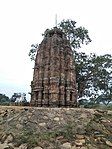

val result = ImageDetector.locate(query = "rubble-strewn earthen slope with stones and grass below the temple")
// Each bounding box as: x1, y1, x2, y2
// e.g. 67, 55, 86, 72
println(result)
0, 106, 112, 149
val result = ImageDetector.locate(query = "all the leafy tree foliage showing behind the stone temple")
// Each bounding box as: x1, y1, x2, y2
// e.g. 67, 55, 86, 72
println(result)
30, 20, 112, 104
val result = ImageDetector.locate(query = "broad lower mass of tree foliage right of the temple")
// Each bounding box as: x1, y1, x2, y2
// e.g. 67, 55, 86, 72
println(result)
74, 53, 112, 103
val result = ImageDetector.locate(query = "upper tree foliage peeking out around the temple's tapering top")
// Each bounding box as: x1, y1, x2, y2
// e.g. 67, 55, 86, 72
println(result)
28, 20, 91, 60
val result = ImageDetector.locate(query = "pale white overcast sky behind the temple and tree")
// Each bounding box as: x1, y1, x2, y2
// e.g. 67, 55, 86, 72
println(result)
0, 0, 112, 100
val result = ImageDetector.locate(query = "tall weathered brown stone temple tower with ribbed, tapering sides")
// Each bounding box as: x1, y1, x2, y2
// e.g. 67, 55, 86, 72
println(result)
30, 27, 77, 107
